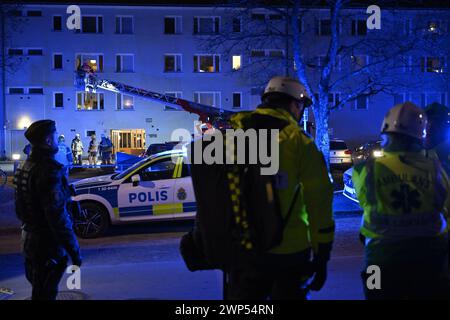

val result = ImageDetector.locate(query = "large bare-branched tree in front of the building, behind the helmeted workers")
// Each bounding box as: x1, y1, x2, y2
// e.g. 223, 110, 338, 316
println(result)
201, 0, 450, 163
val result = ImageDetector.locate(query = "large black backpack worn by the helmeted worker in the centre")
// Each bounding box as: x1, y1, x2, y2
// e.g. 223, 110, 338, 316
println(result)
180, 113, 299, 271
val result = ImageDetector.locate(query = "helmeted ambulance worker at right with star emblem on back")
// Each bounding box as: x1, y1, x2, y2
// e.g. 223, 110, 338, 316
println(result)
352, 102, 450, 299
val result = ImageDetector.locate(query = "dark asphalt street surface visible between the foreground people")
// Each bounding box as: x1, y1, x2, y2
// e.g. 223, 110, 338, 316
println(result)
0, 165, 363, 300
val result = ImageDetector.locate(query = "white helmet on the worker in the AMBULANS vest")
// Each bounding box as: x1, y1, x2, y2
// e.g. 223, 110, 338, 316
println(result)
381, 101, 427, 140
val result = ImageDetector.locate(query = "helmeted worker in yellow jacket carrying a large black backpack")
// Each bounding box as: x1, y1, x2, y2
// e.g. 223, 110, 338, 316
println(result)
229, 77, 334, 299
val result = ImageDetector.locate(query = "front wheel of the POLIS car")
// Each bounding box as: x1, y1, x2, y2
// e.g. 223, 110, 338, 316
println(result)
74, 202, 109, 239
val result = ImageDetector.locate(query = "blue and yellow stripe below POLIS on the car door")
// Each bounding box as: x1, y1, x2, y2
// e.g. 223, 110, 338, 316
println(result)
119, 202, 197, 218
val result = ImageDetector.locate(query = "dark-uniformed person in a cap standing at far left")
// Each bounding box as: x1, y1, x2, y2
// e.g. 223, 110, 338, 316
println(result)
14, 120, 82, 300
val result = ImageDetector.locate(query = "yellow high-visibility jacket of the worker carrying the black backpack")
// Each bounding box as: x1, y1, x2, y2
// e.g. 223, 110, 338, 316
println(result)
231, 108, 334, 254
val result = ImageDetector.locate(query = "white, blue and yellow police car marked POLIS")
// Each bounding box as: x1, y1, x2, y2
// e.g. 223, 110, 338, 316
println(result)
74, 150, 196, 238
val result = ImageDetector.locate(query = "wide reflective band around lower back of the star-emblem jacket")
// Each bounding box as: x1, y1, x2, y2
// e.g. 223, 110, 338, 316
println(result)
363, 213, 447, 238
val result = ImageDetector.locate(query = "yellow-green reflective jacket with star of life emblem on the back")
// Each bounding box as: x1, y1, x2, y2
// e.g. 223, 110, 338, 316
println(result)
352, 151, 450, 240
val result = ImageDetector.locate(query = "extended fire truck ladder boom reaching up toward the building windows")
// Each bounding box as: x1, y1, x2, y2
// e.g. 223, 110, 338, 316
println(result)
75, 70, 234, 127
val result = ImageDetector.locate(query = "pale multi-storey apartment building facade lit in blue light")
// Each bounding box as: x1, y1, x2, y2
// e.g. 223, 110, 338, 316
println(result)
4, 4, 450, 157
